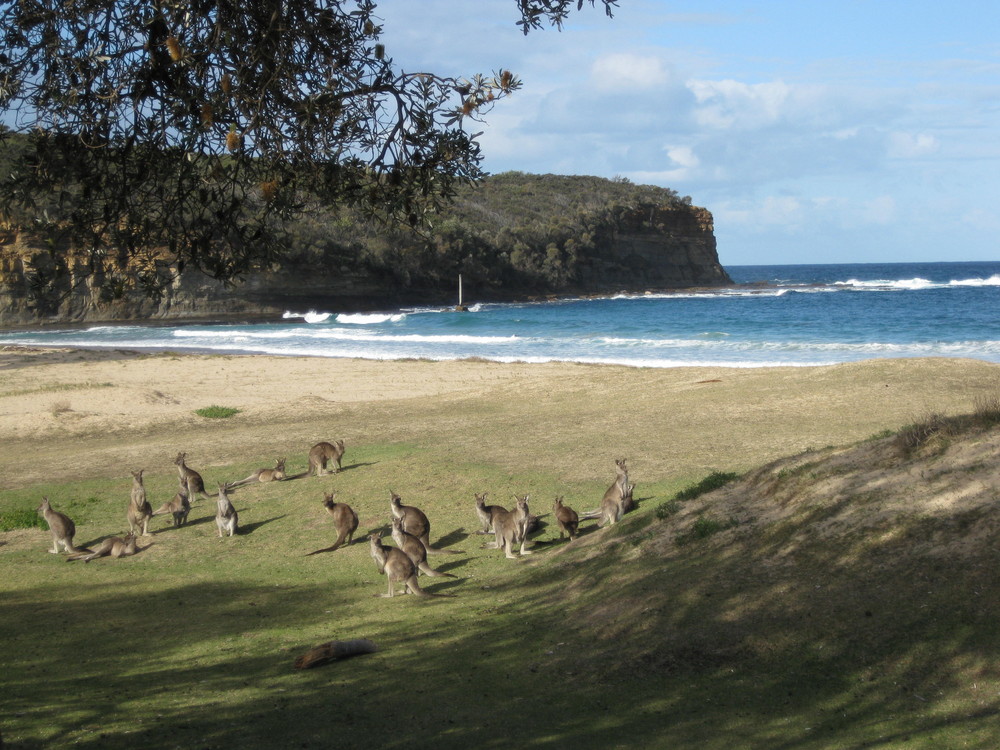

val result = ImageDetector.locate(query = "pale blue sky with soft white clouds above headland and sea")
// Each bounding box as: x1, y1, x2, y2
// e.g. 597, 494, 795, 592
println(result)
377, 0, 1000, 265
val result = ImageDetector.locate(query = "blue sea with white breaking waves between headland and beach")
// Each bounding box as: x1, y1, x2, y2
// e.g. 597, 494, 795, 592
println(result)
0, 262, 1000, 367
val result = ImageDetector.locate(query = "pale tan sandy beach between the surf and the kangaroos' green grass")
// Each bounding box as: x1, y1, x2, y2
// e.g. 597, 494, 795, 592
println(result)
0, 347, 1000, 488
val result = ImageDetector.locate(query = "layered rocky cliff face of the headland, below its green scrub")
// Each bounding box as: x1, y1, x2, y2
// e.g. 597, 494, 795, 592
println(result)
0, 176, 731, 327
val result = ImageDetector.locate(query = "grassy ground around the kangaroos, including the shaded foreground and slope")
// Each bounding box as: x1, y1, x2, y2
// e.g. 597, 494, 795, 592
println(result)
0, 356, 1000, 750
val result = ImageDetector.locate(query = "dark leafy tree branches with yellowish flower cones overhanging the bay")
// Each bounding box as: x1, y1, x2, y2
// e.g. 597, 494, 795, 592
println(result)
0, 0, 616, 294
